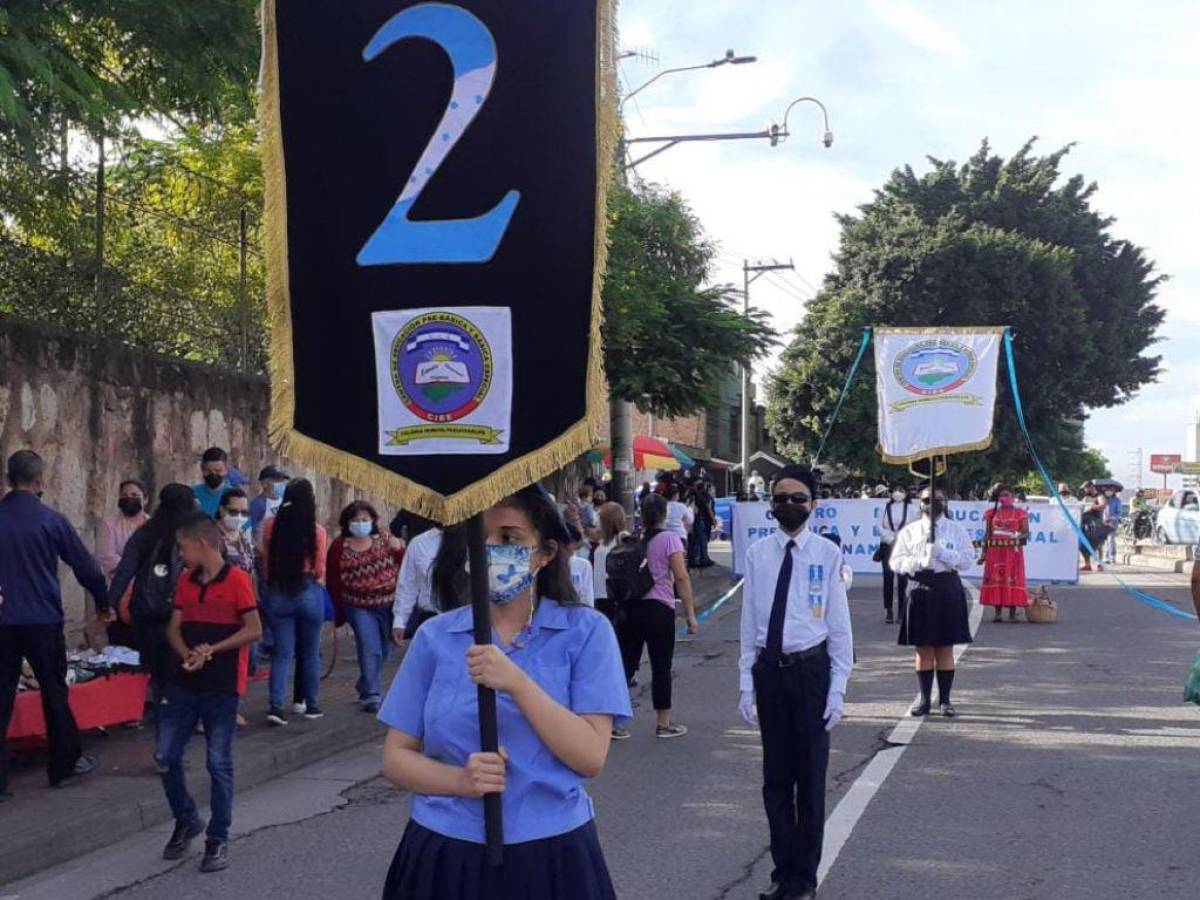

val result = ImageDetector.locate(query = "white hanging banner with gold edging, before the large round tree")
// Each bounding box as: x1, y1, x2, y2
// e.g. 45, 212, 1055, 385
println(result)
875, 328, 1004, 463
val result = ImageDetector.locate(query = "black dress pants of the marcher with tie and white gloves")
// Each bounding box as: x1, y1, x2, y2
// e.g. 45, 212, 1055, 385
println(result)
751, 644, 829, 894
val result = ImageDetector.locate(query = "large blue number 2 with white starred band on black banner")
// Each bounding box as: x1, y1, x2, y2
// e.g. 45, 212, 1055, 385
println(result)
358, 4, 521, 265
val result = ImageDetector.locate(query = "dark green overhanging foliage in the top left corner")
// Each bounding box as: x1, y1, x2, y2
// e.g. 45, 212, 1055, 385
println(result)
0, 0, 258, 154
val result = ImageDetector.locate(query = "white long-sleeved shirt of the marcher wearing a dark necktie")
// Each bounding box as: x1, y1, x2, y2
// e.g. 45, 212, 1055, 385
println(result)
738, 528, 854, 694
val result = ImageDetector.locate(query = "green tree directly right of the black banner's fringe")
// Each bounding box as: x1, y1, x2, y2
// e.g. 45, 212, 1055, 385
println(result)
604, 184, 775, 416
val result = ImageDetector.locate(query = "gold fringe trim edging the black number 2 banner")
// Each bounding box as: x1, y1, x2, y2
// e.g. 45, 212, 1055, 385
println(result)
259, 0, 618, 524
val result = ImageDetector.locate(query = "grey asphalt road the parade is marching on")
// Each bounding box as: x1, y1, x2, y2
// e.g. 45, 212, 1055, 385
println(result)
11, 561, 1200, 900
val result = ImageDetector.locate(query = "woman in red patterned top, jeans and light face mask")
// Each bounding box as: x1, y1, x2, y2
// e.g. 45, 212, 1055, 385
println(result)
325, 500, 404, 713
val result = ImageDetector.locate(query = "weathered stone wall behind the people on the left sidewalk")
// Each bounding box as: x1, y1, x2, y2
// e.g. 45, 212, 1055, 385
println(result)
0, 314, 367, 642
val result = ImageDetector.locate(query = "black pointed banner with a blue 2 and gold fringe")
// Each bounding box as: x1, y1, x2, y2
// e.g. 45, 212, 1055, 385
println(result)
263, 0, 613, 522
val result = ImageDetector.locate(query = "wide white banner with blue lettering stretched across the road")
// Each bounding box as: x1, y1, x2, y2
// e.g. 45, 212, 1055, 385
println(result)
733, 500, 1079, 583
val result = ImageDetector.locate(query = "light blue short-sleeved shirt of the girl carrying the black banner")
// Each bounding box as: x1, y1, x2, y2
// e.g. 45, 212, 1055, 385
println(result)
379, 600, 632, 844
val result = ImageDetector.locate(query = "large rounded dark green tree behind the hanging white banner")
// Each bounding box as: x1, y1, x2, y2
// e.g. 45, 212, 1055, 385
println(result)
768, 140, 1163, 486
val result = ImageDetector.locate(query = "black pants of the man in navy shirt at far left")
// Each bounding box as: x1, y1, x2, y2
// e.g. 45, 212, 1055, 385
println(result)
0, 624, 83, 791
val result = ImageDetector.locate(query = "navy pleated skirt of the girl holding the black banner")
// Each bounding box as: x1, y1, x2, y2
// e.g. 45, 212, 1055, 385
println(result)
383, 820, 617, 900
